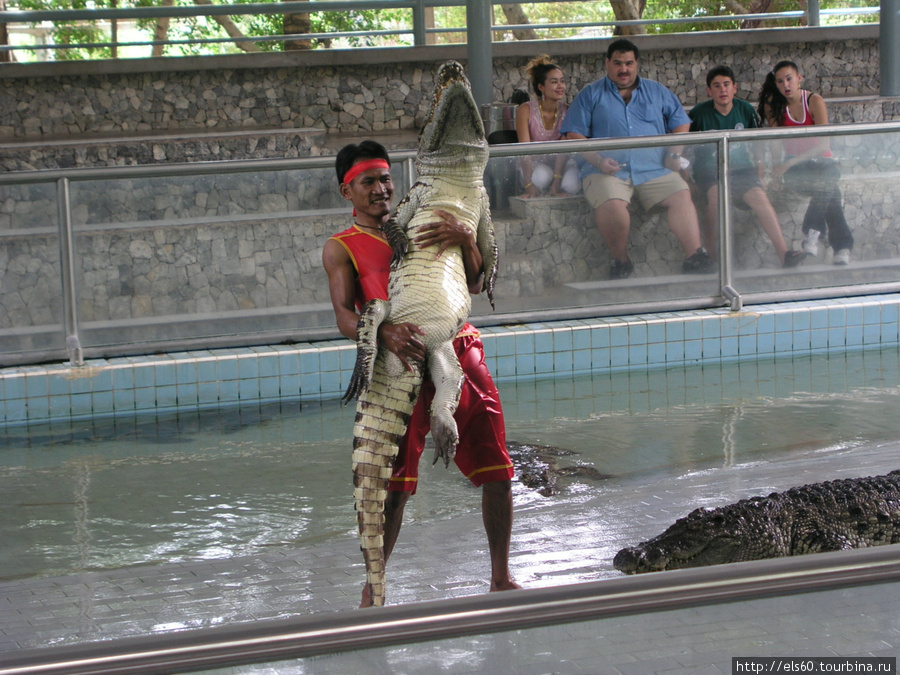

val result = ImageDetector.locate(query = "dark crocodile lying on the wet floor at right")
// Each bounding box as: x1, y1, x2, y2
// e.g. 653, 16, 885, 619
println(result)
613, 471, 900, 574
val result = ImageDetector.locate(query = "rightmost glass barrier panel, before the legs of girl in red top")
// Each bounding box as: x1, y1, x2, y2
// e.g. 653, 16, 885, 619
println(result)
729, 131, 900, 293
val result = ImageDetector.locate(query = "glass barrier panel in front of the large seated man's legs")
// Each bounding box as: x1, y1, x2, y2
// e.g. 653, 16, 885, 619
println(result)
475, 141, 719, 324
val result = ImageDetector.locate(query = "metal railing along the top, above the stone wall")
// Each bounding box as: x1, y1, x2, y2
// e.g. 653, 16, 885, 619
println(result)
0, 0, 879, 55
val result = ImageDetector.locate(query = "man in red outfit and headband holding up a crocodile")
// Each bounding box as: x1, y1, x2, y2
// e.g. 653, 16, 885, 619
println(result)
322, 141, 519, 607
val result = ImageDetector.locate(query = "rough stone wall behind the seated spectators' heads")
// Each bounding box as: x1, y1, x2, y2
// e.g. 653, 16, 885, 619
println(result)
0, 26, 879, 148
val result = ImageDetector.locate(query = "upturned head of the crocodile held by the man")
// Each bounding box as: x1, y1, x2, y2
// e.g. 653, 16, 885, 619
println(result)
416, 61, 488, 180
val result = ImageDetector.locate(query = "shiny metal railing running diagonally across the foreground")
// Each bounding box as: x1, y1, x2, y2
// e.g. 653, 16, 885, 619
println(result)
0, 545, 900, 675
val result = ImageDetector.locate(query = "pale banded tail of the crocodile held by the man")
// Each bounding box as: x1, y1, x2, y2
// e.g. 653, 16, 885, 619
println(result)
353, 352, 422, 606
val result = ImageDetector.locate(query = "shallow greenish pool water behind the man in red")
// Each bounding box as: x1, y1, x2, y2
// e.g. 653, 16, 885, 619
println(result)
0, 348, 900, 580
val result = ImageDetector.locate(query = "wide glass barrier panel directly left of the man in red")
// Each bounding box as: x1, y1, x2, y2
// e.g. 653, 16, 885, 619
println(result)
72, 167, 405, 354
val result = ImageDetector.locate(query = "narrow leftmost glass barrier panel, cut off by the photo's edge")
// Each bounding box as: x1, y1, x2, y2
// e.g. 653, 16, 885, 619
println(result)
0, 183, 65, 357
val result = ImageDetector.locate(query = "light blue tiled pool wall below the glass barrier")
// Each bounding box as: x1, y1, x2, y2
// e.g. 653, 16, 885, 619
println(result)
0, 294, 900, 426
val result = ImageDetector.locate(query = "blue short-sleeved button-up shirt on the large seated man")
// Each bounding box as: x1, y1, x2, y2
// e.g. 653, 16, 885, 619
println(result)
561, 77, 691, 185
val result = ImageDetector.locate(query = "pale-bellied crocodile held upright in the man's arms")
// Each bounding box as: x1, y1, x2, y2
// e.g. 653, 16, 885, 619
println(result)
344, 61, 497, 605
